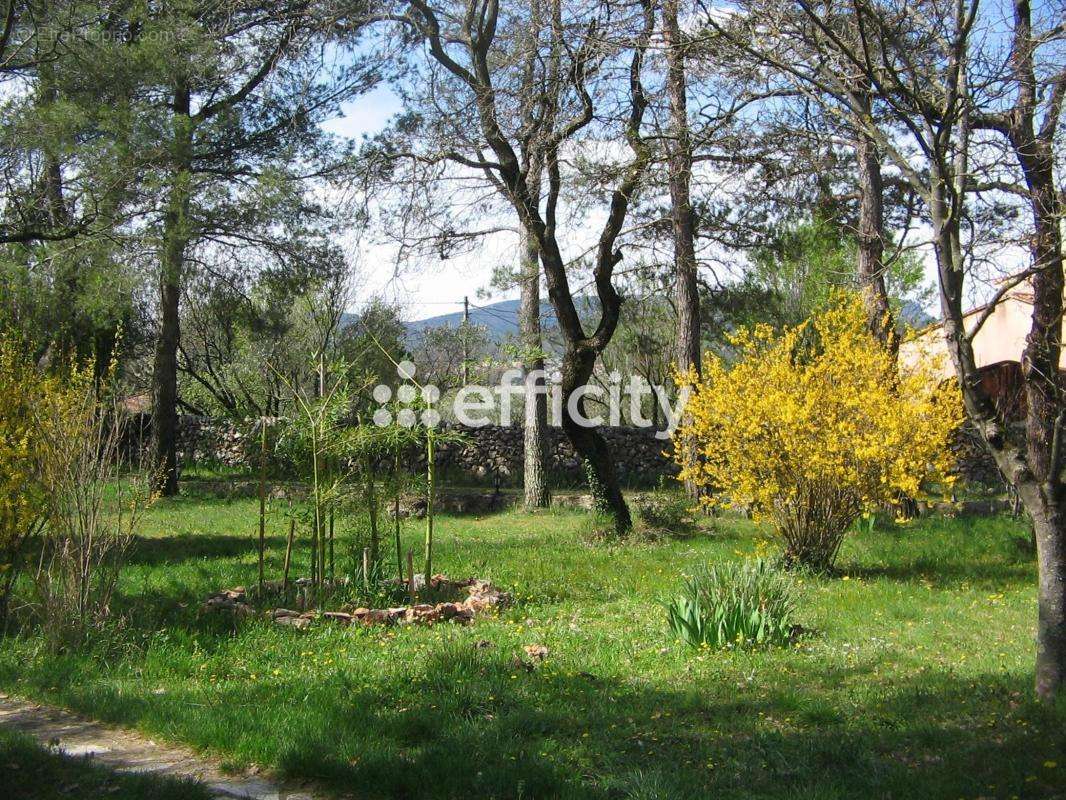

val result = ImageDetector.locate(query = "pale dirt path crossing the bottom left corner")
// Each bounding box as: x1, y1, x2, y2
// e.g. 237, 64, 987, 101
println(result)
0, 694, 326, 800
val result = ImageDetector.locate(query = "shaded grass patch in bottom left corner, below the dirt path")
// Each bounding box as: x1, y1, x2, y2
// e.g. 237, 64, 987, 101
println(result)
0, 727, 210, 800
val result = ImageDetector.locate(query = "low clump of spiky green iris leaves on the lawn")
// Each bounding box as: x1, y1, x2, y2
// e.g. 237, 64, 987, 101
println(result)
666, 559, 795, 647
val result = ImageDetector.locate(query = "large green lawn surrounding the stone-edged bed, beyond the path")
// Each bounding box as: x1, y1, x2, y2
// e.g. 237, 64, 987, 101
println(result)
0, 498, 1066, 799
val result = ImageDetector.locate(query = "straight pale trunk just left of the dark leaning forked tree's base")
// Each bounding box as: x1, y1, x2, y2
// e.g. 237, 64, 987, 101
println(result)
518, 233, 551, 510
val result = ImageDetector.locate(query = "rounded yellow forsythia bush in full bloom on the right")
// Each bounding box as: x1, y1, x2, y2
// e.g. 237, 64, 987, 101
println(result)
675, 294, 963, 570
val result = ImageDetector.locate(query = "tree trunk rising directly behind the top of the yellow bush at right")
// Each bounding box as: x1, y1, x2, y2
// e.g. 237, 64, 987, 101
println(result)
855, 85, 900, 355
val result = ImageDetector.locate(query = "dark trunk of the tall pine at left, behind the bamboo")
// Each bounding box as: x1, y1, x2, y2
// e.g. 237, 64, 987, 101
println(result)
151, 85, 192, 497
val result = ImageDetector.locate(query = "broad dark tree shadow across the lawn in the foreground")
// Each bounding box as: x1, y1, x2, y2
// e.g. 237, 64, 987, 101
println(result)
108, 641, 1066, 799
